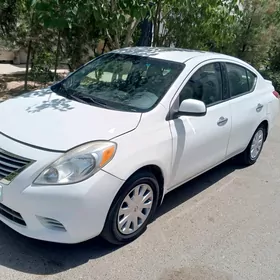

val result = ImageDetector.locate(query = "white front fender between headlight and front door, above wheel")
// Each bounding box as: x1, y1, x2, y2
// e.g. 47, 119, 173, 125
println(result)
103, 118, 172, 188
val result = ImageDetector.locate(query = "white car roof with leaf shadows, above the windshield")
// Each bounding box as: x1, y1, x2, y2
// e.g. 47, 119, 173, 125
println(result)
112, 47, 233, 63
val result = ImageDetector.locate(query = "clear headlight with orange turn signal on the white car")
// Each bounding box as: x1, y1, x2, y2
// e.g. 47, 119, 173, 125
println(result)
34, 141, 116, 185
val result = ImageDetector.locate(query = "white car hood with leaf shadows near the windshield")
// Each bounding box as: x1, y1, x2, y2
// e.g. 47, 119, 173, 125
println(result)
0, 89, 141, 151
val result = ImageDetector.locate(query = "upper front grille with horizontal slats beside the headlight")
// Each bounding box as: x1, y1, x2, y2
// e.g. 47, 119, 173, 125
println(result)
0, 149, 32, 184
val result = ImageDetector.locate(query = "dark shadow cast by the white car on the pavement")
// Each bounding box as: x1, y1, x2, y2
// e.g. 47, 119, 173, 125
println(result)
0, 161, 245, 275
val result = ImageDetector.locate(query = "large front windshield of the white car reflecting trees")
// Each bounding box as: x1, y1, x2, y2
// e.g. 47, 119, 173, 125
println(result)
52, 53, 184, 112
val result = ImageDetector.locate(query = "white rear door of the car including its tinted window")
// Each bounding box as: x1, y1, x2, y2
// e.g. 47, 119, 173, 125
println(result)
225, 63, 267, 157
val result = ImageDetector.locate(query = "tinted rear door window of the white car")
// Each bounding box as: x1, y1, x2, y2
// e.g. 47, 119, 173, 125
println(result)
226, 63, 257, 96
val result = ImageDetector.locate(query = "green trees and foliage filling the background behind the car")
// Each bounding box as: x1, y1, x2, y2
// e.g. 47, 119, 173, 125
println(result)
0, 0, 280, 88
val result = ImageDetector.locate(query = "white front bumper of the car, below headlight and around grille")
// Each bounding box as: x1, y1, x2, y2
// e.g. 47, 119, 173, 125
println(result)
0, 136, 123, 243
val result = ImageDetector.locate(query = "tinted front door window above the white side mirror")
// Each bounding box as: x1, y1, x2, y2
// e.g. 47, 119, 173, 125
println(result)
180, 63, 223, 105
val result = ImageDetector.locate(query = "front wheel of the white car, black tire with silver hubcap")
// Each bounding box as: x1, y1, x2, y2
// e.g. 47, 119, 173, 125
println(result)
101, 171, 159, 245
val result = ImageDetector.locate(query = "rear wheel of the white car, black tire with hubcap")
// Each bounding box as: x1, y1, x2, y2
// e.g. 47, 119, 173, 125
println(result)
239, 125, 266, 166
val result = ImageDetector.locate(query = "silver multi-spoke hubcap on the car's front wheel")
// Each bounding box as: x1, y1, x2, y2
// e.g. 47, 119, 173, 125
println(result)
117, 184, 154, 235
